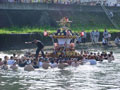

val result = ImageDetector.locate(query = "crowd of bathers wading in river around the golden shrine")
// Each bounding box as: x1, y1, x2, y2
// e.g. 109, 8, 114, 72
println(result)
0, 51, 114, 71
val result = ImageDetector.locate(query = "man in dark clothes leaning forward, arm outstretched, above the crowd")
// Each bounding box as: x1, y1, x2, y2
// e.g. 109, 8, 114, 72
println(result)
25, 39, 45, 59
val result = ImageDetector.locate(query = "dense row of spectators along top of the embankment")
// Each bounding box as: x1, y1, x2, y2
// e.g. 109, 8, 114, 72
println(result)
0, 0, 120, 7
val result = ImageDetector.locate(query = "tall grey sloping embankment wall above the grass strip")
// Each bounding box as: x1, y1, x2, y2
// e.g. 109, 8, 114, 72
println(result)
0, 3, 120, 28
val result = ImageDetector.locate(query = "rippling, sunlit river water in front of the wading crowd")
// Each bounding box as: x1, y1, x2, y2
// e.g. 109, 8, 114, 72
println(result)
0, 48, 120, 90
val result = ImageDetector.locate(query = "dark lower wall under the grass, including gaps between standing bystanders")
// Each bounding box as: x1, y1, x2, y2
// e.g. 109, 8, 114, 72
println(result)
0, 32, 120, 51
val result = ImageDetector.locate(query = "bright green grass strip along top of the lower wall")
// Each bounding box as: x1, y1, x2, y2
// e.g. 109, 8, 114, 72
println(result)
0, 27, 120, 34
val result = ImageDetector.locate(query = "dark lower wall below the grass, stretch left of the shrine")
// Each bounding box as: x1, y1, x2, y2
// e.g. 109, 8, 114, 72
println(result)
0, 34, 52, 51
